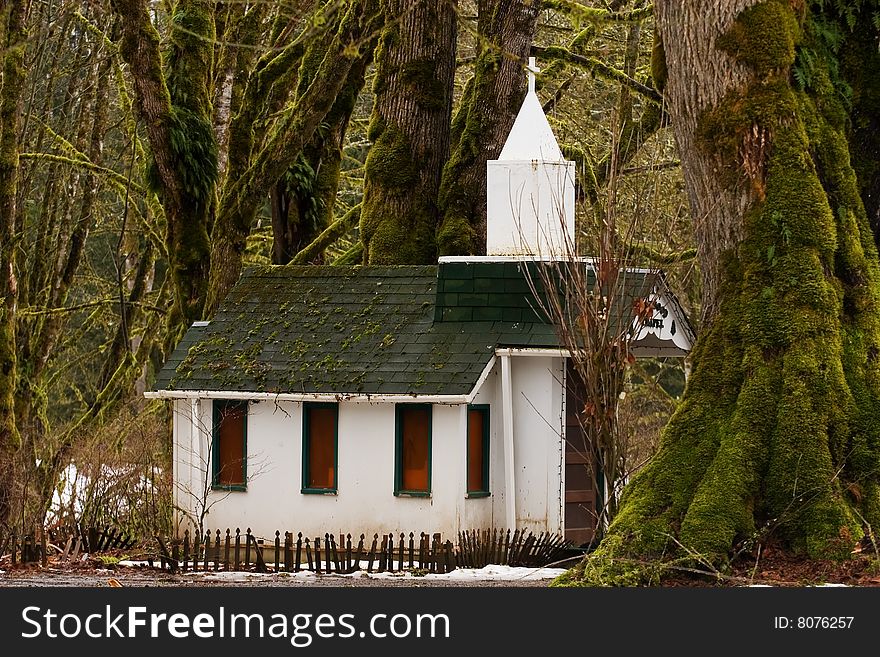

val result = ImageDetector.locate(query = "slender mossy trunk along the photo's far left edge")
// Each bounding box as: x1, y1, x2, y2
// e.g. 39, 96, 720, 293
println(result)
0, 0, 27, 530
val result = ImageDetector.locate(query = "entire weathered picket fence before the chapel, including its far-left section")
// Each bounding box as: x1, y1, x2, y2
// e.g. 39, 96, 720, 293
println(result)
0, 526, 571, 574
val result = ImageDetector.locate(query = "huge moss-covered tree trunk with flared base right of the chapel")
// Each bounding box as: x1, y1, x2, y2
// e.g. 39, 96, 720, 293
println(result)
574, 0, 880, 583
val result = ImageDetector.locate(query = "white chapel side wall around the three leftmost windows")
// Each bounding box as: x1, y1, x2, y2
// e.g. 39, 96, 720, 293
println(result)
174, 400, 466, 539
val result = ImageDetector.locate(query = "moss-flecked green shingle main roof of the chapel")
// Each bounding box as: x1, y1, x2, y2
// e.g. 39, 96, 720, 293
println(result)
153, 266, 557, 395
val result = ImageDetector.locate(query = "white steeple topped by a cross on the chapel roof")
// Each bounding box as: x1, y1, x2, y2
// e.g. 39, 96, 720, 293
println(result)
486, 57, 574, 256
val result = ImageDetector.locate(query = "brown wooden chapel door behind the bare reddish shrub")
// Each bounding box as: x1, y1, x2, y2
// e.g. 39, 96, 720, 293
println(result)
565, 364, 597, 546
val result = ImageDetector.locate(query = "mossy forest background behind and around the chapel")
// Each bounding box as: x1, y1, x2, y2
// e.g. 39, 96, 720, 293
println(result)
0, 0, 700, 552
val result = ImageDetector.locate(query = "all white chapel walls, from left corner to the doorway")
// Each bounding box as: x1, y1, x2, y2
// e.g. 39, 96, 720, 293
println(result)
174, 356, 564, 540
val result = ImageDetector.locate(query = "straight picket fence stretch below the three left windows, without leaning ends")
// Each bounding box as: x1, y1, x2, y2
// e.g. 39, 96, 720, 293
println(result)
156, 529, 457, 574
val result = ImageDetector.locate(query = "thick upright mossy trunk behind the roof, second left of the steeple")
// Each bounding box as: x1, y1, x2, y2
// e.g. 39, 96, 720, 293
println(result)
360, 0, 457, 264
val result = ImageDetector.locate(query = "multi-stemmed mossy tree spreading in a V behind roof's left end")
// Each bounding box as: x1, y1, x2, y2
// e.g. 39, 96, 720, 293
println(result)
113, 0, 379, 320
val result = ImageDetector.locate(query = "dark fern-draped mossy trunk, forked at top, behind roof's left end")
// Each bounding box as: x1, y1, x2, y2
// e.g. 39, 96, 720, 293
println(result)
112, 0, 217, 326
